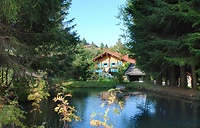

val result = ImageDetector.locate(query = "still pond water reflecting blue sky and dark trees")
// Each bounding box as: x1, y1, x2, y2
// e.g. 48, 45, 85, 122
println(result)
24, 89, 200, 128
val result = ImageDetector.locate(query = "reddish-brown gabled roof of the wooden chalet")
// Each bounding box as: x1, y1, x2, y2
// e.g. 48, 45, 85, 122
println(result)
93, 51, 136, 64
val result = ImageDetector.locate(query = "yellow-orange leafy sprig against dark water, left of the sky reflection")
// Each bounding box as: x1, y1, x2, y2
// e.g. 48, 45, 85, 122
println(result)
53, 93, 80, 123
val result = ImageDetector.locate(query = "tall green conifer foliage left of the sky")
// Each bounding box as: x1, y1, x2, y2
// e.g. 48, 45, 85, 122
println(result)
0, 0, 78, 85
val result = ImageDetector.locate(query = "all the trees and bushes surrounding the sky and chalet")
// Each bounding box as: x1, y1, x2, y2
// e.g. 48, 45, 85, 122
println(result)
0, 0, 200, 126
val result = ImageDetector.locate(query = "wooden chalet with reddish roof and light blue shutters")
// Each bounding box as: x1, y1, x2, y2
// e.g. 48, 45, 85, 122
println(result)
93, 51, 136, 74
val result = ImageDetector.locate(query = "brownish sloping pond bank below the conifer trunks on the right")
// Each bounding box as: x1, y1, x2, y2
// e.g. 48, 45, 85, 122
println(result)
127, 83, 200, 102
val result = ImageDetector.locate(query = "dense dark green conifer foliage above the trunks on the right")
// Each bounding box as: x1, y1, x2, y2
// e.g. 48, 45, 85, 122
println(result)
119, 0, 200, 87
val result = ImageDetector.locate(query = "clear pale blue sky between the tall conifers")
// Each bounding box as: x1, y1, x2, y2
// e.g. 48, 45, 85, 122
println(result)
68, 0, 126, 47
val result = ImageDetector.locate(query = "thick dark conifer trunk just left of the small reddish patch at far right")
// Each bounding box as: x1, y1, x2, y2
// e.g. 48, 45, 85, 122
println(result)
180, 65, 187, 88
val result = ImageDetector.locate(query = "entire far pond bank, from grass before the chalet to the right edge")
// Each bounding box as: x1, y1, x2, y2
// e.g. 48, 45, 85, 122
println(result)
62, 81, 200, 102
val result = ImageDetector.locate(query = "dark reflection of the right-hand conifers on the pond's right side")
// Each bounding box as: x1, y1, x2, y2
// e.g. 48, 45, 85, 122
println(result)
126, 95, 200, 128
